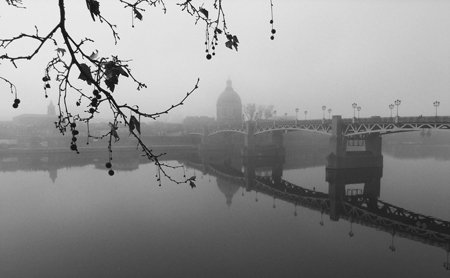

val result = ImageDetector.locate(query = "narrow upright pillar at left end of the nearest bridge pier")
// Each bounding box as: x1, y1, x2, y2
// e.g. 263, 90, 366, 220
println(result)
327, 115, 347, 168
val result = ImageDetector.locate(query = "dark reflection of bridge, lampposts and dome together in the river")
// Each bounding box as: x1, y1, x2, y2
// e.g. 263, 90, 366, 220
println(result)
188, 148, 450, 270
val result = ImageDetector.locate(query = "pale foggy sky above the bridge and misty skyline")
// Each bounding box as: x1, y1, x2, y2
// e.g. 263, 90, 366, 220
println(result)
0, 0, 450, 120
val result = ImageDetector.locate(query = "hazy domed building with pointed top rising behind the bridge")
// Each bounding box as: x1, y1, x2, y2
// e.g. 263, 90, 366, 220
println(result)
216, 79, 242, 123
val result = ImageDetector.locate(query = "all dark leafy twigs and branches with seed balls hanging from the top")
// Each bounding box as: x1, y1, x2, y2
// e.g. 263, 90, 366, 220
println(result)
0, 0, 250, 183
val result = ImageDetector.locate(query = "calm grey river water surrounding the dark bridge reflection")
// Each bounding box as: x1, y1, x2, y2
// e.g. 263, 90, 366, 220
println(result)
0, 144, 450, 277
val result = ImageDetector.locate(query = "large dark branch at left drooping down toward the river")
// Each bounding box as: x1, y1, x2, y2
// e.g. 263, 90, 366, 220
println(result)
0, 0, 204, 184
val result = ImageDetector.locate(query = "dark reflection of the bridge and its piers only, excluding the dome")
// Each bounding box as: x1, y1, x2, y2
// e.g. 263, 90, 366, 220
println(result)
188, 155, 450, 253
